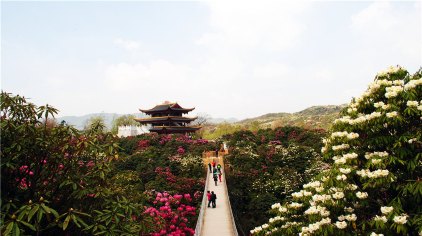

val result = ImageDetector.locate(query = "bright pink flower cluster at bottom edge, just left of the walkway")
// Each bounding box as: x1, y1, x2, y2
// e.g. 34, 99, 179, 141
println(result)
144, 192, 196, 236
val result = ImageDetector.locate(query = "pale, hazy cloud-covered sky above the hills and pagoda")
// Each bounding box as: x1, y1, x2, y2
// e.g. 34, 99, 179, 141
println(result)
1, 0, 422, 119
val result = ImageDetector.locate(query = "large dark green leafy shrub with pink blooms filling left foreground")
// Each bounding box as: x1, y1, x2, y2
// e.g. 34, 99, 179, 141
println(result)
0, 92, 142, 235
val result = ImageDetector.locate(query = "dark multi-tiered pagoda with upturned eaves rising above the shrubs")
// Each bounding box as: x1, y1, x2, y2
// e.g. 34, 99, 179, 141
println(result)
135, 101, 201, 134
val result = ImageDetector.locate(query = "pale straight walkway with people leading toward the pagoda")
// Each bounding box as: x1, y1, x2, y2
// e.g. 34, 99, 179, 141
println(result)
200, 157, 237, 236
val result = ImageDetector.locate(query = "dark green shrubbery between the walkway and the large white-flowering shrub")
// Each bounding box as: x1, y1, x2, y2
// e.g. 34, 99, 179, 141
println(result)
223, 127, 324, 231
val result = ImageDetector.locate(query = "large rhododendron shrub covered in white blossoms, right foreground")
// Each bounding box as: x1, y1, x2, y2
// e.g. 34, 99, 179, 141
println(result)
251, 67, 422, 235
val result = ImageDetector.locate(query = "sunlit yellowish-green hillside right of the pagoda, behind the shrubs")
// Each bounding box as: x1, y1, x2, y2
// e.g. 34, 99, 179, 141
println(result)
237, 105, 346, 129
